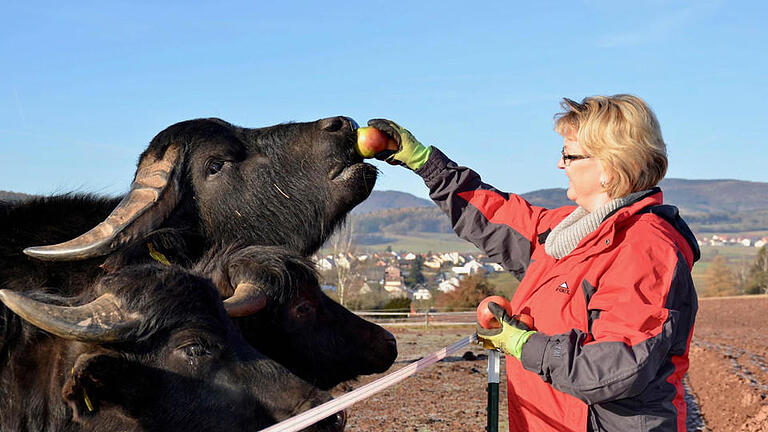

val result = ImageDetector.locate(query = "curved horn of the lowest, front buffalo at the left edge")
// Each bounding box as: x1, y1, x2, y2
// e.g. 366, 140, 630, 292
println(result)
0, 289, 139, 342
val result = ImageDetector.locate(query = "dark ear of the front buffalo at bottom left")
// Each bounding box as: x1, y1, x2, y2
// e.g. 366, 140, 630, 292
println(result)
61, 352, 141, 423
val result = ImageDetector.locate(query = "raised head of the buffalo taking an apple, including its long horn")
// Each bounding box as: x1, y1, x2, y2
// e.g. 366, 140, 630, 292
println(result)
24, 117, 377, 261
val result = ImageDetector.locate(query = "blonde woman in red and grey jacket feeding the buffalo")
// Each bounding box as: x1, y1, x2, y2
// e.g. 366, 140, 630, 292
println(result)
369, 95, 699, 432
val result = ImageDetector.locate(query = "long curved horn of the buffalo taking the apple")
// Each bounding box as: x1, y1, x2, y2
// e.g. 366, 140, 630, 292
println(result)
24, 144, 180, 261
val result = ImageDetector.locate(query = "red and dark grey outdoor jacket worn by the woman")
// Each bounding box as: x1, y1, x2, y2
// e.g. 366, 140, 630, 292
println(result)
416, 149, 699, 432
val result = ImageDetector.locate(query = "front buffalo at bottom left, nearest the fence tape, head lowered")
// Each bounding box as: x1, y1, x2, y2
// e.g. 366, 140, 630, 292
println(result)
0, 264, 344, 432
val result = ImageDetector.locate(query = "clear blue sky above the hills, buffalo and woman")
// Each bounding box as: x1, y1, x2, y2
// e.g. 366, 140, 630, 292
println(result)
0, 0, 768, 197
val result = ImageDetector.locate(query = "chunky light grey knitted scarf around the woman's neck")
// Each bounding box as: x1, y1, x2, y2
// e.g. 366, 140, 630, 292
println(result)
544, 190, 648, 259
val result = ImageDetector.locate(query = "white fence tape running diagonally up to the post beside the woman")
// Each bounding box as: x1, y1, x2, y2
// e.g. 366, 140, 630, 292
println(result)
255, 335, 475, 432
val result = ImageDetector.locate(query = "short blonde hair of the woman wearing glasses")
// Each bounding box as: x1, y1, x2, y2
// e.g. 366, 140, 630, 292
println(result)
555, 94, 667, 198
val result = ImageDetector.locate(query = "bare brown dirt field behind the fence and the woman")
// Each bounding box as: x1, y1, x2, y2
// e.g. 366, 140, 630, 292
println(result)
334, 296, 768, 432
